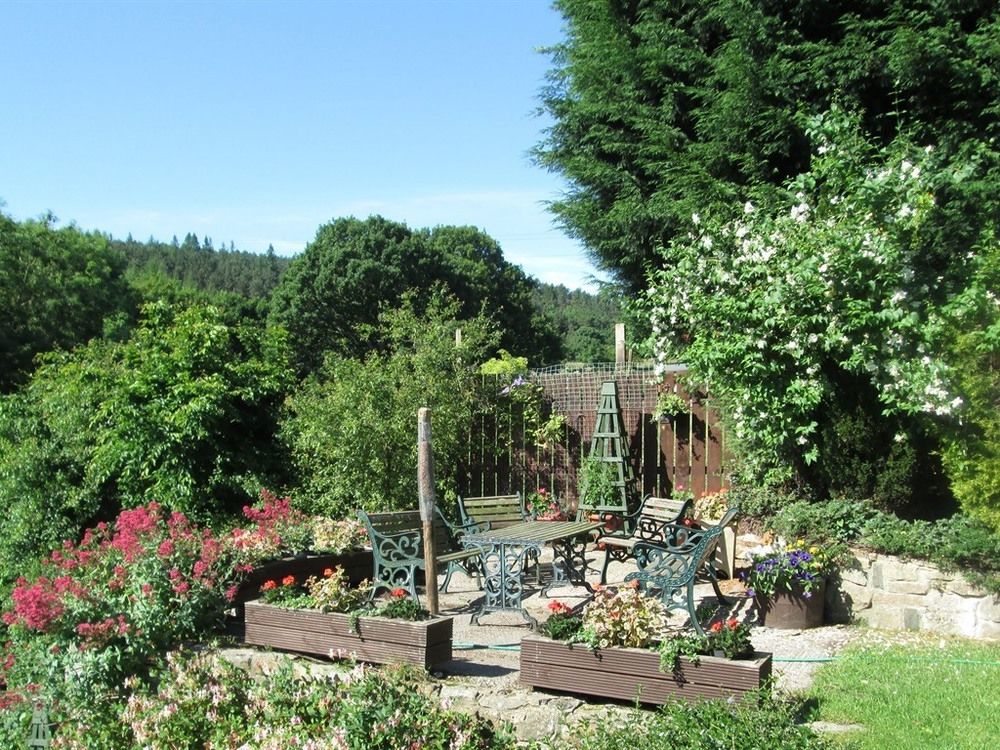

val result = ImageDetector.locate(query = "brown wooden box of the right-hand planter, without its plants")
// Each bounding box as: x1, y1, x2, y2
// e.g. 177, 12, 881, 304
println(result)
521, 635, 771, 705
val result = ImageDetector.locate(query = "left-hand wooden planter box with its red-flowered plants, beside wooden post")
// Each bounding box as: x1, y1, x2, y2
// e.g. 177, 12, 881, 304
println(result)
244, 568, 452, 669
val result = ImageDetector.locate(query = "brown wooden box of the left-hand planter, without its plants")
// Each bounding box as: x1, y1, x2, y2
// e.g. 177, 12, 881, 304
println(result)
244, 601, 452, 669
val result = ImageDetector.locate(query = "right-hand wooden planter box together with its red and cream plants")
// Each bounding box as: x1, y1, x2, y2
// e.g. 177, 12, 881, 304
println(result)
521, 586, 771, 704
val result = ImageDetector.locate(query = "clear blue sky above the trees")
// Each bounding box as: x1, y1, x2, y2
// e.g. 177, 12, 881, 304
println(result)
0, 0, 595, 287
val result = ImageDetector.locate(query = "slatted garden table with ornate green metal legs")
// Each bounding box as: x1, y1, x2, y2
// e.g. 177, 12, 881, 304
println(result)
462, 521, 604, 628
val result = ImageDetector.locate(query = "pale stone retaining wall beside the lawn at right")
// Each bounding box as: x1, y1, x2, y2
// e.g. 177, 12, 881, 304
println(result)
826, 550, 1000, 640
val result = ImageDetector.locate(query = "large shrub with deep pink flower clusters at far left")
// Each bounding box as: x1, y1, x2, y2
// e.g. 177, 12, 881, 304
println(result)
0, 503, 234, 704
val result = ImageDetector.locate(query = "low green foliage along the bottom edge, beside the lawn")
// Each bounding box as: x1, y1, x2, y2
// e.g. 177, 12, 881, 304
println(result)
558, 691, 837, 750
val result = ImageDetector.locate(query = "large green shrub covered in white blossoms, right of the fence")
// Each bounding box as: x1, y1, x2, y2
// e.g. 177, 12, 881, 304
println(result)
650, 110, 982, 503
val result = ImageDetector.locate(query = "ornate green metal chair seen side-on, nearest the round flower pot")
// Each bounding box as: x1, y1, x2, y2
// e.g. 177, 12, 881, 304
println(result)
625, 506, 739, 635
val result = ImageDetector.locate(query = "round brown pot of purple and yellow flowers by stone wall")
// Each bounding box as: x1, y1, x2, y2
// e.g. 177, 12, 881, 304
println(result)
741, 539, 843, 629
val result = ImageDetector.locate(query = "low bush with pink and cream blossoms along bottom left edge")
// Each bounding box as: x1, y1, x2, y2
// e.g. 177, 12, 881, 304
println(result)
43, 653, 513, 750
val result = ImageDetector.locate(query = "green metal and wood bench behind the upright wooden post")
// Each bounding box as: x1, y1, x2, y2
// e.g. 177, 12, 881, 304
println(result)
358, 508, 483, 599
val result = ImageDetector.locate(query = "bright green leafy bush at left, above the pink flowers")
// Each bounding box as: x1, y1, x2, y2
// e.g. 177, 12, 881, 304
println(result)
0, 305, 291, 580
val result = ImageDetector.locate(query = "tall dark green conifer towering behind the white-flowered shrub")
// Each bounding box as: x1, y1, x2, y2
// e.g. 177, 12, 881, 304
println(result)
535, 0, 1000, 291
